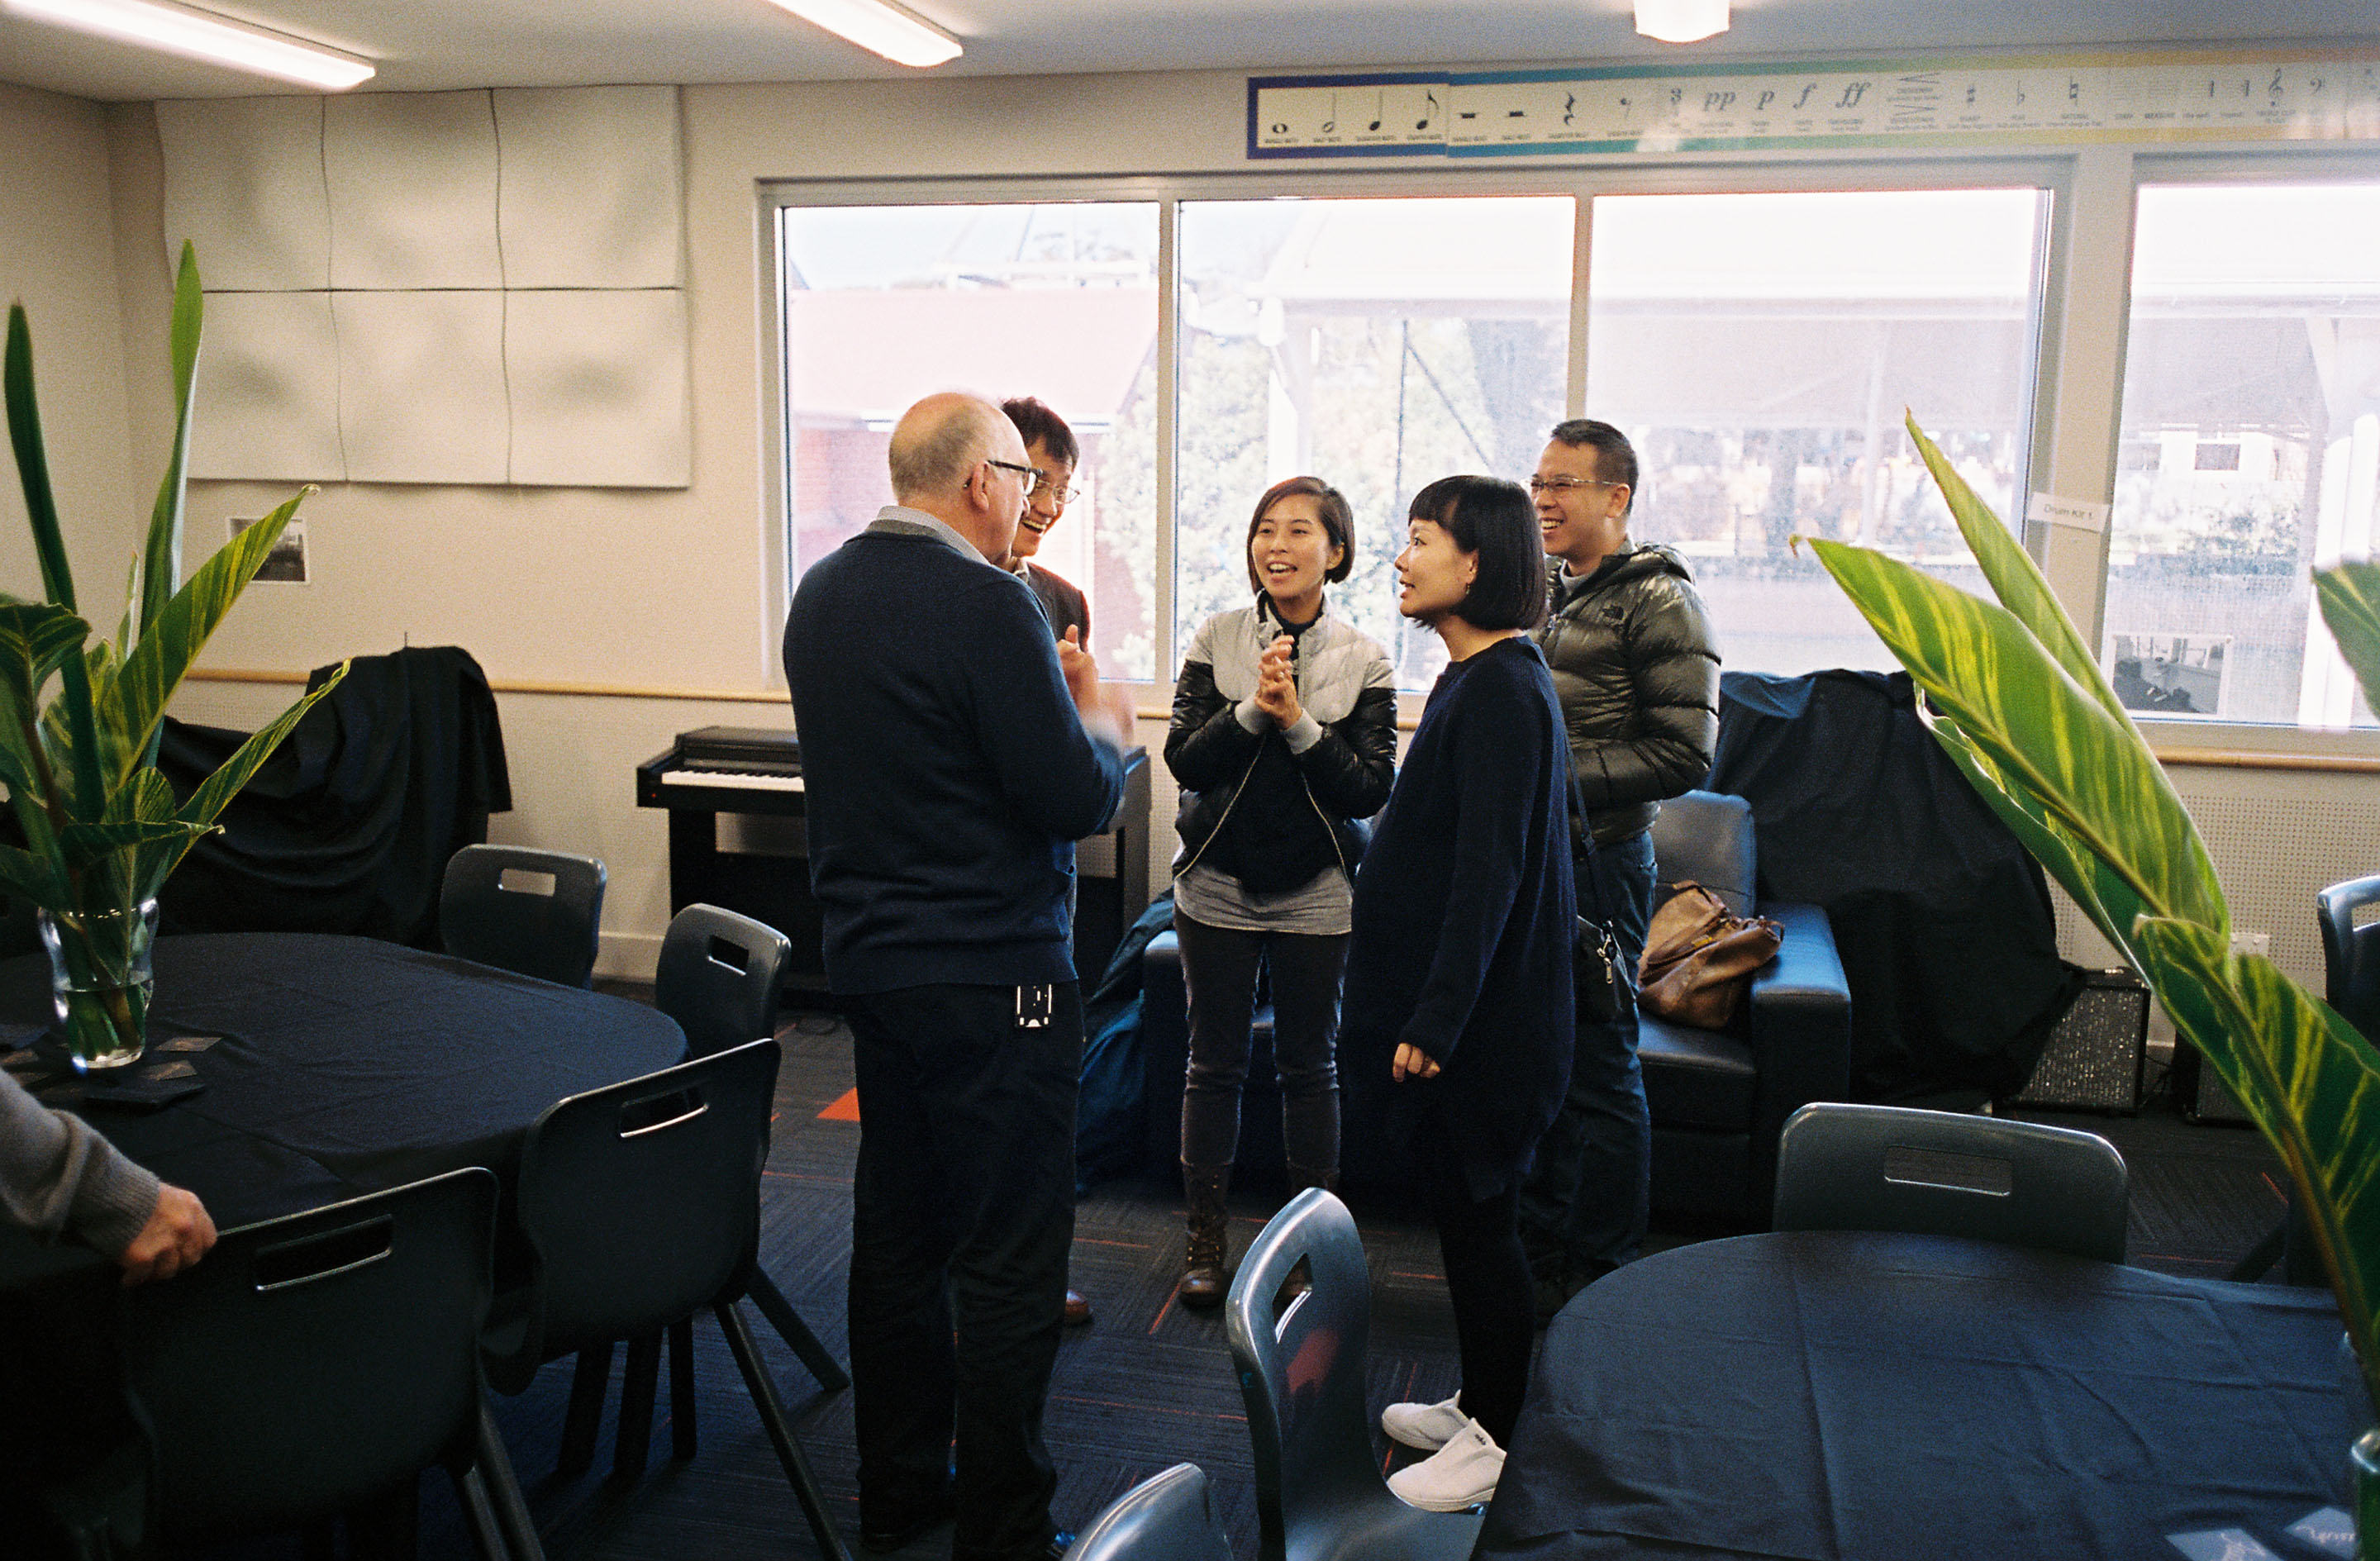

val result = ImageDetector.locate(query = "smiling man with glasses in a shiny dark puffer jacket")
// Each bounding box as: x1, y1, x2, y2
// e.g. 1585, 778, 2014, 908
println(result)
1521, 419, 1718, 1321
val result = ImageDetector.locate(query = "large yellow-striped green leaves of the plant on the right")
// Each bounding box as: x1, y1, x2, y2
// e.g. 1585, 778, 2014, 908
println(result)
1797, 416, 2380, 1561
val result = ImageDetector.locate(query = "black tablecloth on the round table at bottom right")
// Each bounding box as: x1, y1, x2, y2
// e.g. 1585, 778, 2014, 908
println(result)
1478, 1233, 2349, 1561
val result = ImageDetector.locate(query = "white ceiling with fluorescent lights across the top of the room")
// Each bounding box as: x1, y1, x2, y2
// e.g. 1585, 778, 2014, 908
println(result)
0, 0, 2380, 102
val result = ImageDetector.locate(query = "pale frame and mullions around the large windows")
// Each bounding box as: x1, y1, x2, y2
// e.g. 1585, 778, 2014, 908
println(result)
754, 143, 2380, 759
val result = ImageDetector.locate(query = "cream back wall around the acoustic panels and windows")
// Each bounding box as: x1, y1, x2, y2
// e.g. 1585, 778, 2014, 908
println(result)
74, 74, 2380, 980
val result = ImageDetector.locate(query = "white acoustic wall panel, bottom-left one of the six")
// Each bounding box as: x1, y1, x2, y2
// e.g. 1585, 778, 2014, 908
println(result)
190, 293, 347, 483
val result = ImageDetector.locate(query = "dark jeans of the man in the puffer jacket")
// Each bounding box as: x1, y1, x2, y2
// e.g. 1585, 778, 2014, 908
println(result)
1521, 833, 1654, 1285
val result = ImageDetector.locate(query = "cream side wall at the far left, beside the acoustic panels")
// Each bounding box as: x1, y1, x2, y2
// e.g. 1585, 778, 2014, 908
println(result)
0, 86, 136, 604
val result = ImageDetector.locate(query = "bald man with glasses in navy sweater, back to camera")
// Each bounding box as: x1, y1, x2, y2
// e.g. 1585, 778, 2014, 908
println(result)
785, 395, 1130, 1561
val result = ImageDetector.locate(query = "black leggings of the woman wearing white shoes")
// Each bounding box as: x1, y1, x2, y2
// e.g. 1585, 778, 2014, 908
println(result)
1414, 1123, 1537, 1449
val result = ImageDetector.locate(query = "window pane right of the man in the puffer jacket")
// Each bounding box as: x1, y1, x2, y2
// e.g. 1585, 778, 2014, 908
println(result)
1587, 190, 2042, 673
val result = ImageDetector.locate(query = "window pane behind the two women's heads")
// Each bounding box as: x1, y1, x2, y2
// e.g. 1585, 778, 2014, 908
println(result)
1173, 195, 1576, 688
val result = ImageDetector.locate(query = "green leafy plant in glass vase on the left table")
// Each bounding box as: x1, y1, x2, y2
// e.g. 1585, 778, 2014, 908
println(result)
0, 243, 345, 1071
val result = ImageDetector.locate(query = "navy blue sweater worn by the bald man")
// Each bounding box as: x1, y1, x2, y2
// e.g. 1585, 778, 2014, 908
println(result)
785, 512, 1123, 992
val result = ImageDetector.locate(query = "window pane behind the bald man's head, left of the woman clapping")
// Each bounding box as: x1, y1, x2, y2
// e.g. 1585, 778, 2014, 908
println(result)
778, 202, 1157, 678
